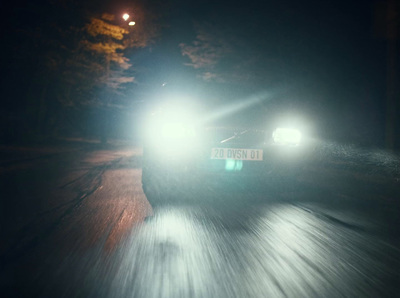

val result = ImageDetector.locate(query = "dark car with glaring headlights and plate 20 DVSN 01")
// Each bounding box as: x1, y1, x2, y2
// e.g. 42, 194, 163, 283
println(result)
142, 98, 307, 206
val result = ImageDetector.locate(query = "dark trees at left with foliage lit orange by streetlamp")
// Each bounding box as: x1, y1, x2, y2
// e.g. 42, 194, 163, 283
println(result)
0, 0, 158, 142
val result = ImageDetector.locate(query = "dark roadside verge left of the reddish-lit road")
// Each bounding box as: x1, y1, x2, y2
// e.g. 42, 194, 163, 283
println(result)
0, 139, 141, 265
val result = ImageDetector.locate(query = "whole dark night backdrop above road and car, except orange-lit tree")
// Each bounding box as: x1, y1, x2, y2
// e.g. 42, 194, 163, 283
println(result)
0, 0, 399, 148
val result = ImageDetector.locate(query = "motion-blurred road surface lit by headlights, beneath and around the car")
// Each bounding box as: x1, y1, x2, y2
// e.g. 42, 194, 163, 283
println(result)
0, 141, 400, 297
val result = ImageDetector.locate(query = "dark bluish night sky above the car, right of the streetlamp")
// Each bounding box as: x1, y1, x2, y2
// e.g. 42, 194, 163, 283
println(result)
3, 0, 396, 143
